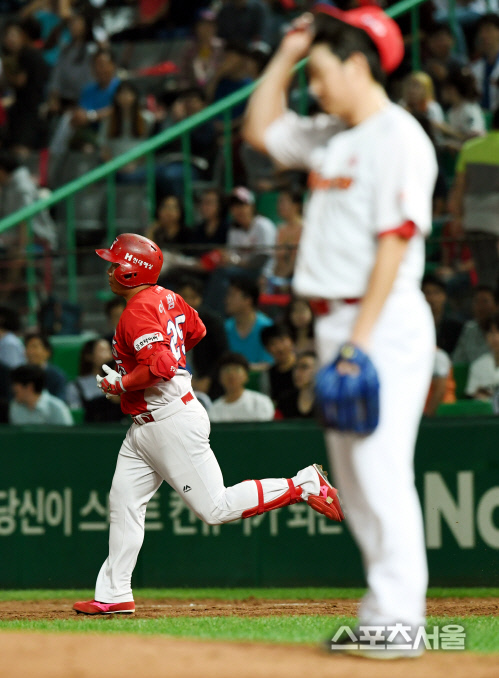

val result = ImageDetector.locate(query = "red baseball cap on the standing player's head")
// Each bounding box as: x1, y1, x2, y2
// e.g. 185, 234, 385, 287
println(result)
314, 4, 404, 73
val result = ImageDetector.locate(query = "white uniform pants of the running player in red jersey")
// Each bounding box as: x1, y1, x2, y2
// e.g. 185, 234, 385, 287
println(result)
95, 398, 319, 603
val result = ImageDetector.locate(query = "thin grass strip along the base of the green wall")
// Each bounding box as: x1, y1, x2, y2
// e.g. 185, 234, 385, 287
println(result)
0, 588, 499, 601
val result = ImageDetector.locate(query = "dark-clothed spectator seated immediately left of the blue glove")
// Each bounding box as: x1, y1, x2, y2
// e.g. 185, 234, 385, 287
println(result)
277, 351, 317, 419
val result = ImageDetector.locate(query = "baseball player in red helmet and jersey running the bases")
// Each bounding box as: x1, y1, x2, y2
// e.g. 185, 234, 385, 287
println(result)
73, 233, 343, 615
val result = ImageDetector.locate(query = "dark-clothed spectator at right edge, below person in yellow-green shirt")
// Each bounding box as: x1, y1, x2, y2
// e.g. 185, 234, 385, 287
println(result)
452, 285, 497, 363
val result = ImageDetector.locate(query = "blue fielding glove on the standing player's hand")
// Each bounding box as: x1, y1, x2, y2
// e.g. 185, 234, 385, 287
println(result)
315, 344, 379, 434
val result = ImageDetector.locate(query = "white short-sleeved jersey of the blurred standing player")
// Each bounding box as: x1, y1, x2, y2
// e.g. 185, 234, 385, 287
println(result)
265, 104, 437, 299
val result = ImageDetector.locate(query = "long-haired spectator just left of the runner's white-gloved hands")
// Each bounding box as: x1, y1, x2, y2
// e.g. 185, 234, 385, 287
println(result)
67, 339, 123, 423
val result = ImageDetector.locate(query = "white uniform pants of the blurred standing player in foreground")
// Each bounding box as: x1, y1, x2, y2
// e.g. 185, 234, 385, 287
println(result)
316, 290, 435, 625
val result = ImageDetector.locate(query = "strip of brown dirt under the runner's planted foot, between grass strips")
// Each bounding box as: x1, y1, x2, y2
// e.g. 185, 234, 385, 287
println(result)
0, 598, 499, 621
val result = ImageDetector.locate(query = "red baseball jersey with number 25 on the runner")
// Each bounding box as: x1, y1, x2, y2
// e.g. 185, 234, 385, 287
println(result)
113, 285, 205, 416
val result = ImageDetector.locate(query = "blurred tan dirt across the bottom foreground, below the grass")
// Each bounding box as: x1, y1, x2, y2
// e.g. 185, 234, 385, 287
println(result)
0, 632, 498, 678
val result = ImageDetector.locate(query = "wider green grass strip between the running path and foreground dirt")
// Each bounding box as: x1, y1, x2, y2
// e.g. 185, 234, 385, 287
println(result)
0, 615, 499, 653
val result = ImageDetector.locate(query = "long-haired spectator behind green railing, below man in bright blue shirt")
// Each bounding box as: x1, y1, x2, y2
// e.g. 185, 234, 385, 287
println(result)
98, 81, 154, 184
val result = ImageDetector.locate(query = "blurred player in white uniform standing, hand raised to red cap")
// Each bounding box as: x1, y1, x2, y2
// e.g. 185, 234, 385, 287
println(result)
243, 5, 437, 659
